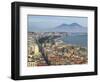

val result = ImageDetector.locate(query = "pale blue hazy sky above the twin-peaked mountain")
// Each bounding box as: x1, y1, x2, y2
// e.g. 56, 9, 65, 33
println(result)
28, 15, 88, 30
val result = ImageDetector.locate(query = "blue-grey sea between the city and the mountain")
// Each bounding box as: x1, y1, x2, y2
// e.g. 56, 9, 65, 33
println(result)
62, 33, 88, 47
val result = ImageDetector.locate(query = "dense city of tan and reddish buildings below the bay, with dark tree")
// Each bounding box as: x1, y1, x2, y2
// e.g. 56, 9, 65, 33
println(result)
27, 32, 88, 67
